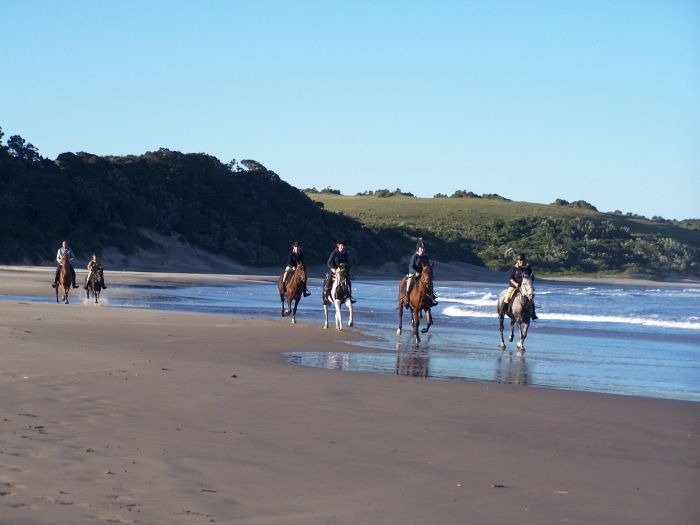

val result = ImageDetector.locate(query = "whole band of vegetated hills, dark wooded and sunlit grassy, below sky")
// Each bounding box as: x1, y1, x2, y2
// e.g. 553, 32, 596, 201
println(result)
0, 125, 700, 276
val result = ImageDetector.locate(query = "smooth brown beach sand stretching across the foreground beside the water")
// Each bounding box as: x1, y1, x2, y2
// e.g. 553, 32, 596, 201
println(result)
0, 267, 700, 525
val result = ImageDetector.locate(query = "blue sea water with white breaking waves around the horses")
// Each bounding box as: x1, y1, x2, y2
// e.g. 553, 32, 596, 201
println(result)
4, 280, 700, 402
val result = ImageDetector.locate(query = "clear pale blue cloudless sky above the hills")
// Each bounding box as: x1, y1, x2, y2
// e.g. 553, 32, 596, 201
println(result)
0, 0, 700, 219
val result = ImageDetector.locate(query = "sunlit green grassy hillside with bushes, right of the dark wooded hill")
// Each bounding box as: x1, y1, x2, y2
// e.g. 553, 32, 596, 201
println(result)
308, 193, 700, 275
